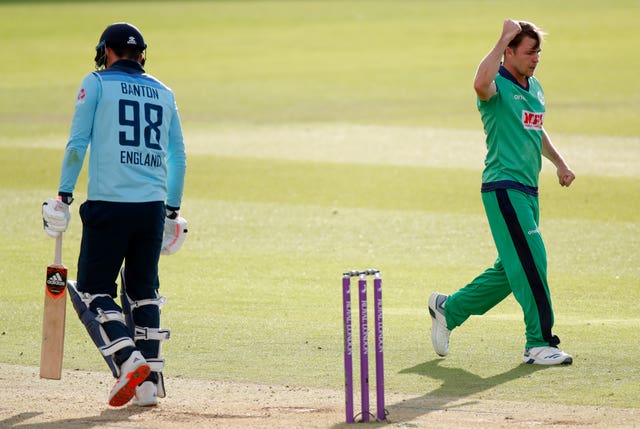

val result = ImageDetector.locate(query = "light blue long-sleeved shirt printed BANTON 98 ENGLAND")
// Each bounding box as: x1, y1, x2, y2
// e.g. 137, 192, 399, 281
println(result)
58, 60, 186, 208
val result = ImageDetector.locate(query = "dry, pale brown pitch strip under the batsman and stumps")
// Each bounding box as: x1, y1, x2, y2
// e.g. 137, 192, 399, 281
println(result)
0, 364, 640, 429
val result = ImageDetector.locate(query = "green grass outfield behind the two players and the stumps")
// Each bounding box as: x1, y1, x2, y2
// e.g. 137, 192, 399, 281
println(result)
0, 1, 640, 414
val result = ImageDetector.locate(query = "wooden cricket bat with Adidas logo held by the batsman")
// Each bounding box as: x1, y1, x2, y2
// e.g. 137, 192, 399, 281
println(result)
40, 233, 67, 380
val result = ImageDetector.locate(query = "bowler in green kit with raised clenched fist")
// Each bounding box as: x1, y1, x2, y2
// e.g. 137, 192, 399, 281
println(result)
429, 19, 575, 365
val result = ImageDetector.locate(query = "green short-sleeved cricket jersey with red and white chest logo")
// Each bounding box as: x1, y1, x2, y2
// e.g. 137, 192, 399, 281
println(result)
477, 66, 545, 191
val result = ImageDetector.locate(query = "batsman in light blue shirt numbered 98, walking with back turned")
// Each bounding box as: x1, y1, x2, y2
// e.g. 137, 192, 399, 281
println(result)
42, 22, 187, 407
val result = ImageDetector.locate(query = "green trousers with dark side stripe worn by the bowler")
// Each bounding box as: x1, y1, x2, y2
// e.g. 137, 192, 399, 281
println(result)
445, 189, 560, 347
